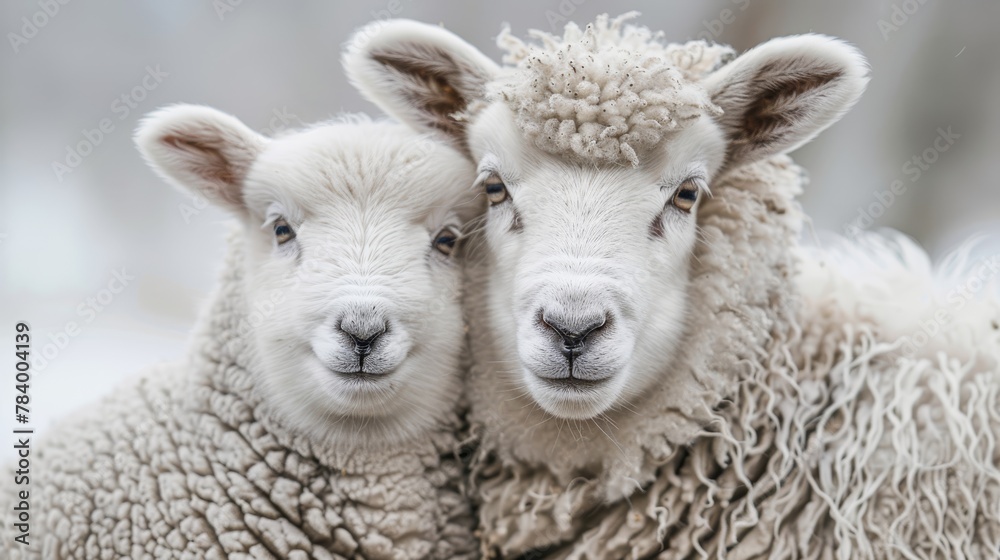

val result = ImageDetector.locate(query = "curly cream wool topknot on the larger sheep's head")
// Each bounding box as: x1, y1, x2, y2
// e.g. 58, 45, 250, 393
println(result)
489, 12, 733, 166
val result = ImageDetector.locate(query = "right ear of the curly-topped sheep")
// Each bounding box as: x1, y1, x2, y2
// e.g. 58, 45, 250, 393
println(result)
704, 35, 868, 167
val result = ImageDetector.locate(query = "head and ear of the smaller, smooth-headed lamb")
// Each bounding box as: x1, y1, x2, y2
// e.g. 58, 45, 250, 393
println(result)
138, 107, 474, 443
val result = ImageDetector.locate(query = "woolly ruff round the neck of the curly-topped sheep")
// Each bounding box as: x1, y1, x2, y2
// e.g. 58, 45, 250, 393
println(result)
467, 157, 802, 498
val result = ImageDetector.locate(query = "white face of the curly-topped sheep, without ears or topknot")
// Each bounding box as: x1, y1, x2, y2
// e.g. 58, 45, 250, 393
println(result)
469, 104, 725, 418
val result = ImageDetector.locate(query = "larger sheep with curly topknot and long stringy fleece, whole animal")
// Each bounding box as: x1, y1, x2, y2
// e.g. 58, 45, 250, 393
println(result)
343, 13, 1000, 559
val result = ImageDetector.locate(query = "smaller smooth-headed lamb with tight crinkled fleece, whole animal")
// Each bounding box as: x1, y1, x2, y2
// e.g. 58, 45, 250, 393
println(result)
3, 105, 478, 559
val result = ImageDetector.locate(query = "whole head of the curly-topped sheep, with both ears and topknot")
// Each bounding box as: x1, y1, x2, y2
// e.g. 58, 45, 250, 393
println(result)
344, 17, 866, 419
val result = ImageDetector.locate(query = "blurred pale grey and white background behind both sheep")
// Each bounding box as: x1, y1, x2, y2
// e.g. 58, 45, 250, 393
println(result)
0, 0, 1000, 457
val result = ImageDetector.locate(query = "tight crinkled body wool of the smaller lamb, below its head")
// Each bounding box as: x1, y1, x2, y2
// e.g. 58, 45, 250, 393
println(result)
0, 232, 475, 560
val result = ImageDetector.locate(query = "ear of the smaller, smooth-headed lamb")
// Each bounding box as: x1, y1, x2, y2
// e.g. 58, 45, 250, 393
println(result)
135, 105, 267, 211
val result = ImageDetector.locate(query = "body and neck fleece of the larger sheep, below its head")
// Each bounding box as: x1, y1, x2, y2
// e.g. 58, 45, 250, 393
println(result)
469, 157, 1000, 559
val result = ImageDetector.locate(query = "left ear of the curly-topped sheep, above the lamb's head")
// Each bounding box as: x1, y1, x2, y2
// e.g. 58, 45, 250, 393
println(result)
342, 20, 499, 154
